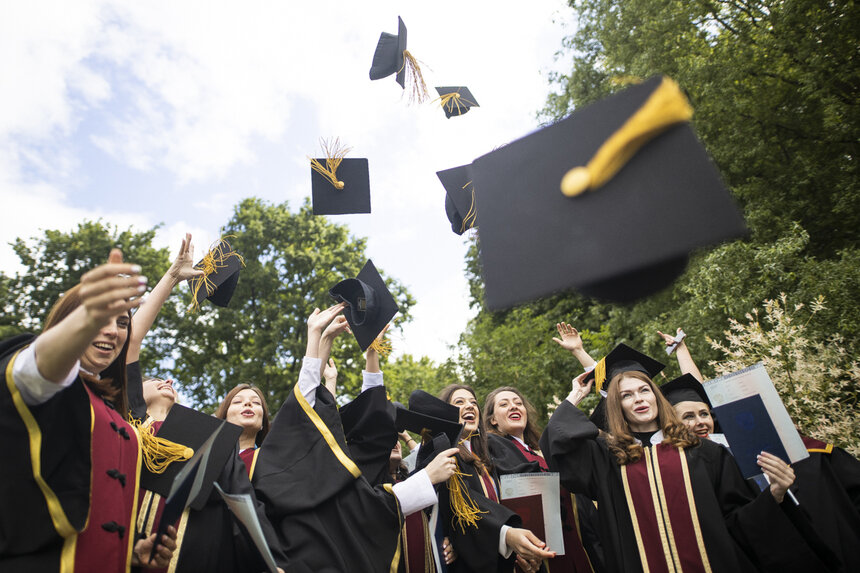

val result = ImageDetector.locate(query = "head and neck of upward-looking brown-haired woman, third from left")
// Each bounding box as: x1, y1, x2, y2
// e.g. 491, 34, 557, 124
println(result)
215, 383, 269, 478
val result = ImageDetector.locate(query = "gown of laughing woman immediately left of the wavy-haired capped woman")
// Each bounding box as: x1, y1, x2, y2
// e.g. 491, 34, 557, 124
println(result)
487, 434, 603, 572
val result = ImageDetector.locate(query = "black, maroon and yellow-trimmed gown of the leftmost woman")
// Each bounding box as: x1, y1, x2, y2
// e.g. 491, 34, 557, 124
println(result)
0, 335, 141, 573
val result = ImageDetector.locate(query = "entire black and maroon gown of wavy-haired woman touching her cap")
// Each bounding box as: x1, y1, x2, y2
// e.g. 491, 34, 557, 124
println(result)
541, 400, 828, 572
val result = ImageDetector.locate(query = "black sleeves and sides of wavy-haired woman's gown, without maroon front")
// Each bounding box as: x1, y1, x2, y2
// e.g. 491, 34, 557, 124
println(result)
541, 401, 818, 573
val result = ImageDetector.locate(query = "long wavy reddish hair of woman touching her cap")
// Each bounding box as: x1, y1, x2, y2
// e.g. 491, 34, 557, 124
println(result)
606, 371, 699, 466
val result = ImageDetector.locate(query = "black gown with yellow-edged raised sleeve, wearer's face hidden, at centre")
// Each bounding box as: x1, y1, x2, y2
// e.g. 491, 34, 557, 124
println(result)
254, 384, 403, 573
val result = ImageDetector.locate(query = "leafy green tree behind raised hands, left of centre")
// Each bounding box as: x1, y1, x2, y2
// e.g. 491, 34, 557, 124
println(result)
160, 199, 414, 411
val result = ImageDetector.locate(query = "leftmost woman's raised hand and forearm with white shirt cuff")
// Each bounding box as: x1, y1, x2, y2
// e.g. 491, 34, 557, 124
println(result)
34, 249, 146, 384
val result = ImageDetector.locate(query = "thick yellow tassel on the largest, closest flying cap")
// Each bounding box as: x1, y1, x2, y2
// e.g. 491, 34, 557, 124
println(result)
561, 78, 693, 197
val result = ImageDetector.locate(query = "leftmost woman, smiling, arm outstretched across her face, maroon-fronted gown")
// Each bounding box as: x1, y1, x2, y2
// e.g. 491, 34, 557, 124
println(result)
0, 249, 176, 572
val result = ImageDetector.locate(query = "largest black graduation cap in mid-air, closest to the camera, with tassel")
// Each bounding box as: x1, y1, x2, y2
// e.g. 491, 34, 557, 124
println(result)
472, 77, 745, 310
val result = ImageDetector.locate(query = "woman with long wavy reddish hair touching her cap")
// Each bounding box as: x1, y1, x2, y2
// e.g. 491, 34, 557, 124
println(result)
540, 345, 817, 571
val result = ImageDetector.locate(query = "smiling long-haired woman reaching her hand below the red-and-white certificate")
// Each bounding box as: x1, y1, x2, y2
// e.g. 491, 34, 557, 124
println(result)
436, 384, 555, 572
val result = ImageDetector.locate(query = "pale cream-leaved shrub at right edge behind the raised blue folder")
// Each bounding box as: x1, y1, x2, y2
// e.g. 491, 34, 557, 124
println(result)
711, 295, 860, 456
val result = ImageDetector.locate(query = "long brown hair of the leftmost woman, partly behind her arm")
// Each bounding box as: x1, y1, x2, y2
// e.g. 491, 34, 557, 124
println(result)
42, 284, 131, 418
